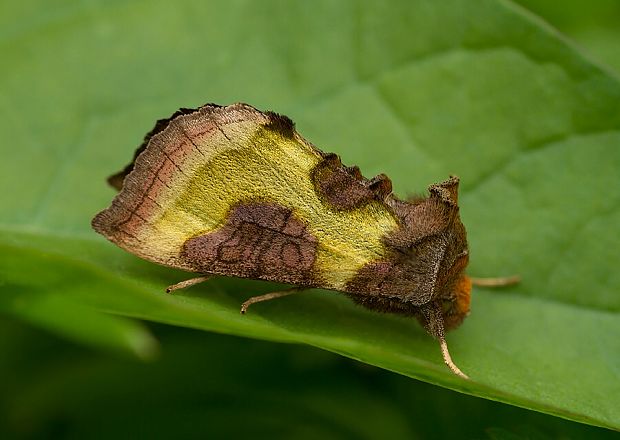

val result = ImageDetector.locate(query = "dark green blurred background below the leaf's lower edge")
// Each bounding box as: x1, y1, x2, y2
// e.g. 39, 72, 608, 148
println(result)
0, 320, 617, 440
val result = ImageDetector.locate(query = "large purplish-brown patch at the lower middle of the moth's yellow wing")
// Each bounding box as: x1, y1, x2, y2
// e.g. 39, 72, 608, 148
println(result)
182, 203, 317, 285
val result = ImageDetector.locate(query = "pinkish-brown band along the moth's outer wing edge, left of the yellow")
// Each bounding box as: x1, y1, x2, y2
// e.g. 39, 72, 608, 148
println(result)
92, 104, 268, 270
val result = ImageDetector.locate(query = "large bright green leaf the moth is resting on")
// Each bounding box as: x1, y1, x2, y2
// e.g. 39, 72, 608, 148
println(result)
0, 0, 620, 429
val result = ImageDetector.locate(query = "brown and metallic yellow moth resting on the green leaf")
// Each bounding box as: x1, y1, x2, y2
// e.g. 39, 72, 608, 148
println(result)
92, 104, 508, 378
